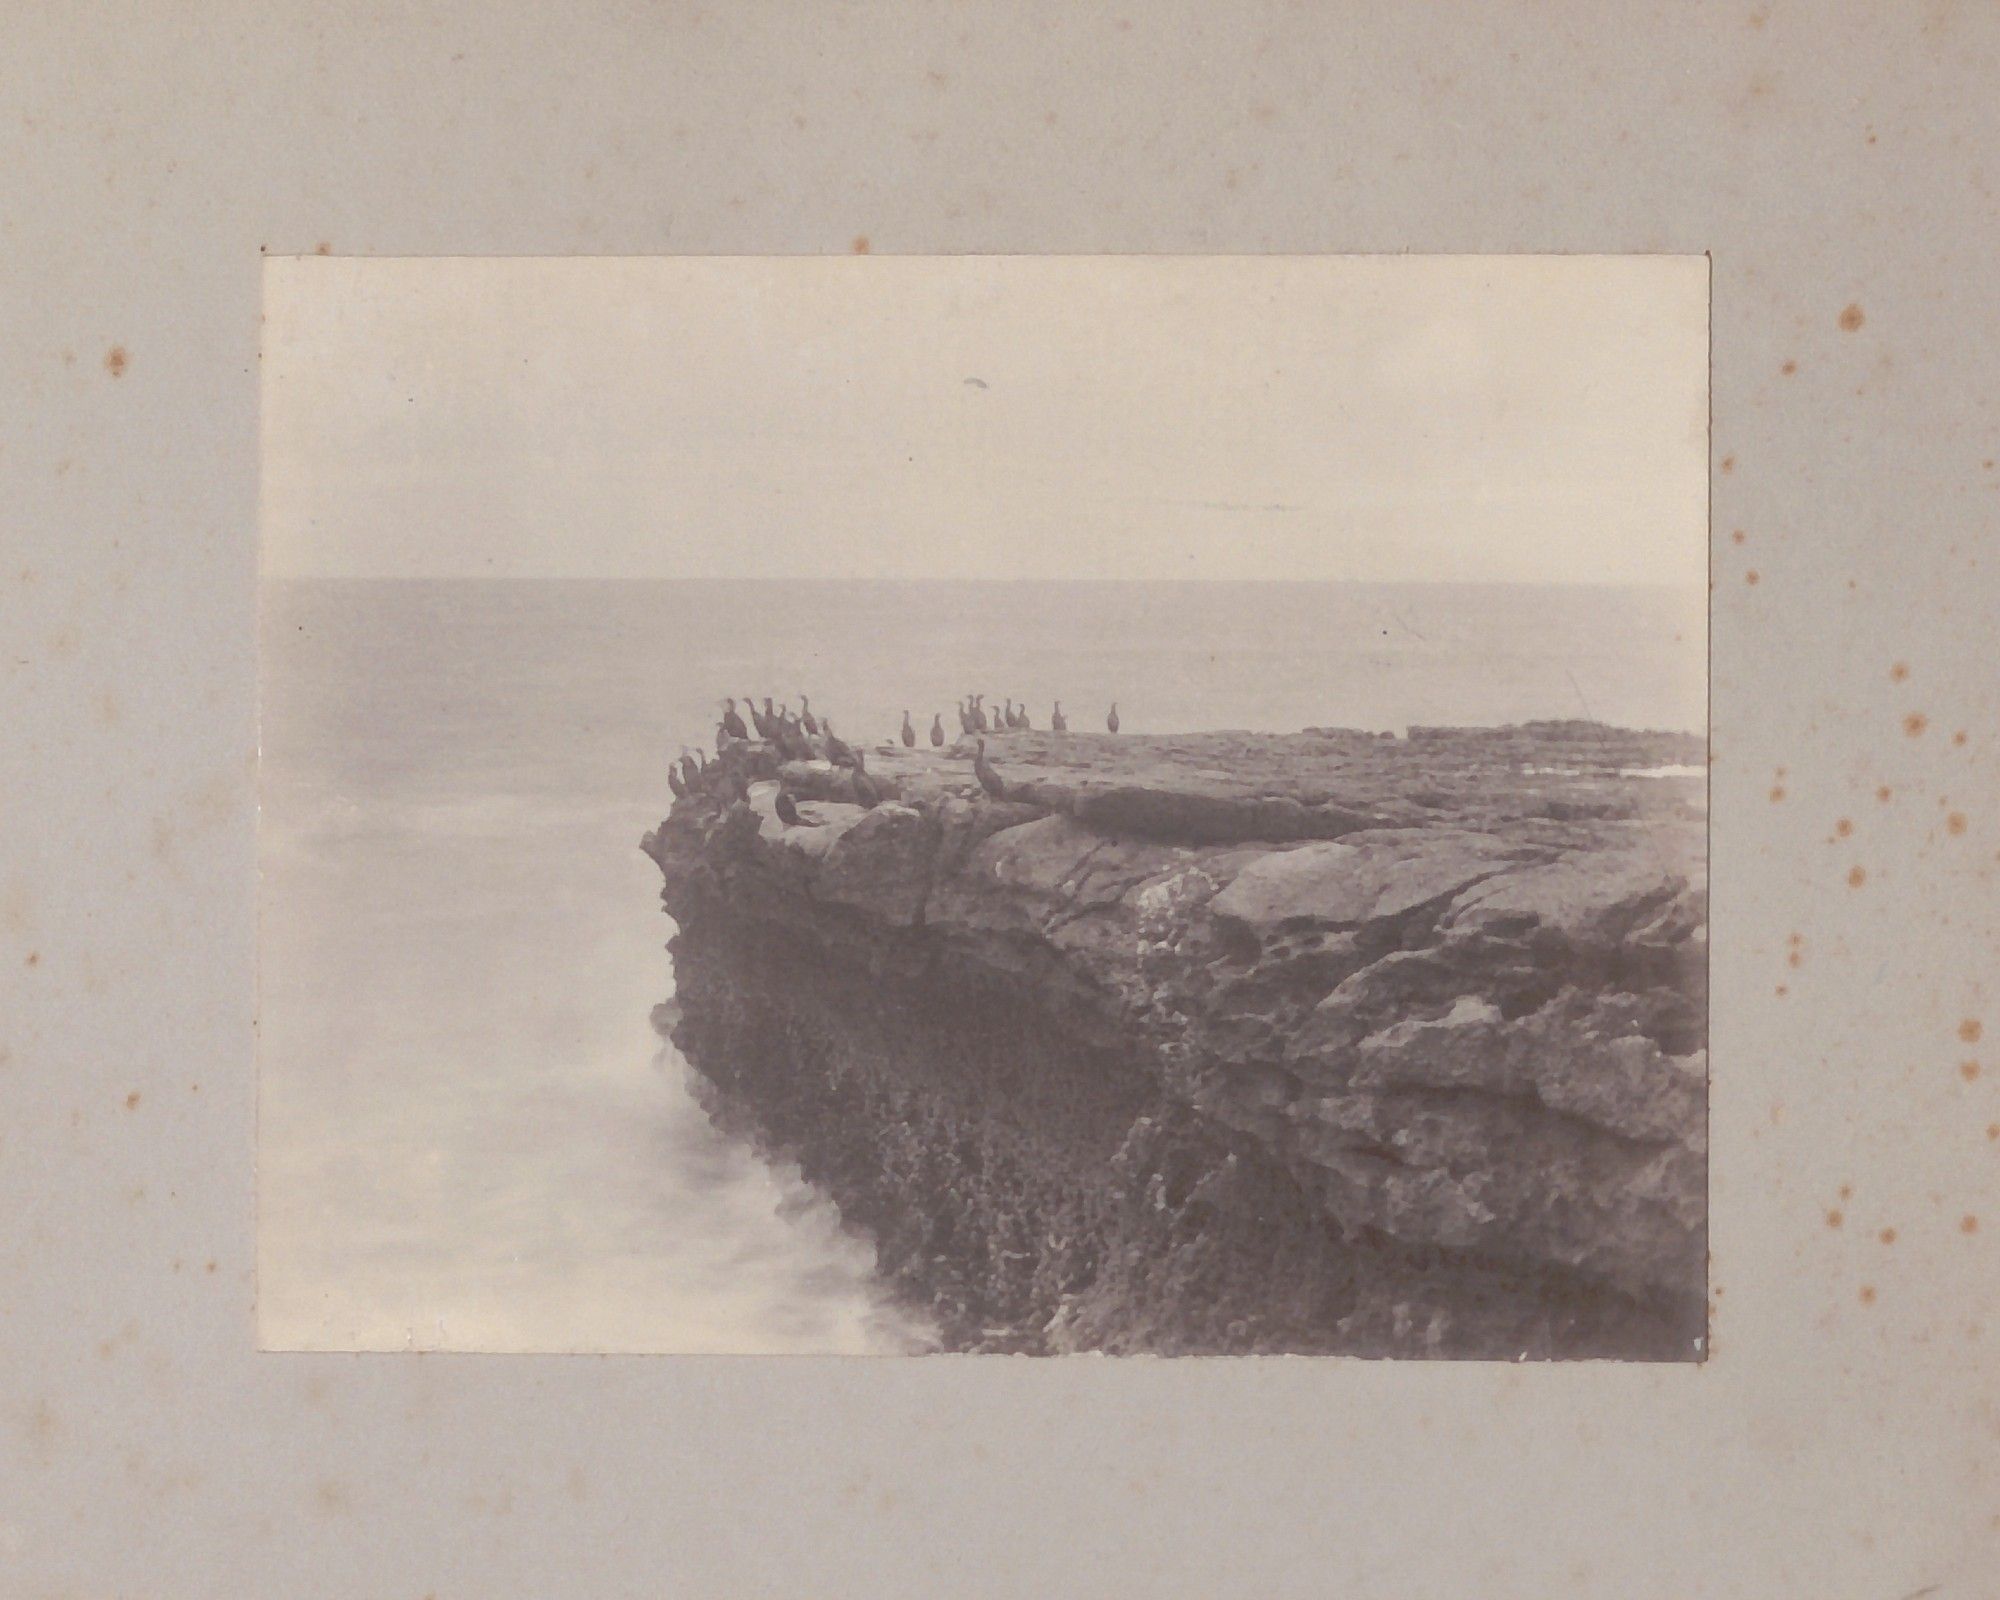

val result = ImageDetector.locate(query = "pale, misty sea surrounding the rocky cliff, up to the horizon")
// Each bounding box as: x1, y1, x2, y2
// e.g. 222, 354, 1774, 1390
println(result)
258, 580, 1706, 1352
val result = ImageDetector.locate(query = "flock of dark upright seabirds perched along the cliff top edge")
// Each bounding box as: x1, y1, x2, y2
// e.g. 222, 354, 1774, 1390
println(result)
666, 694, 1118, 828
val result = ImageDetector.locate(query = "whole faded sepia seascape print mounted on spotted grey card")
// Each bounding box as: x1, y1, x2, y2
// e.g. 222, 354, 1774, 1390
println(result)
256, 254, 1710, 1362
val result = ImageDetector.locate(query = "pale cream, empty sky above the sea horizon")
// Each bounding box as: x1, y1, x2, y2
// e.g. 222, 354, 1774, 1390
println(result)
262, 256, 1708, 590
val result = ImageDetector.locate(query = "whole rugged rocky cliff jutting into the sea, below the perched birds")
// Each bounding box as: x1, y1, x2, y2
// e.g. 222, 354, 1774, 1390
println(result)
646, 724, 1708, 1360
